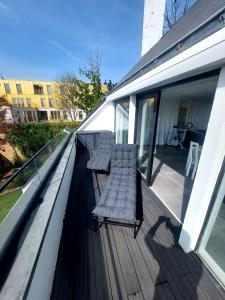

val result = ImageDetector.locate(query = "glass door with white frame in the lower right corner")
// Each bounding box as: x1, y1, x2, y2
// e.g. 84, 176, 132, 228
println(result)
198, 169, 225, 285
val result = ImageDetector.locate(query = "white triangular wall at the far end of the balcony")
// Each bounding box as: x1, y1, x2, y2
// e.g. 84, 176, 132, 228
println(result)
79, 102, 115, 131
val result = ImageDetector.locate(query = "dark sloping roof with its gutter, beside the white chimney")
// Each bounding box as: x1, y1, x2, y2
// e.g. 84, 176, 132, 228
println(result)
112, 0, 225, 92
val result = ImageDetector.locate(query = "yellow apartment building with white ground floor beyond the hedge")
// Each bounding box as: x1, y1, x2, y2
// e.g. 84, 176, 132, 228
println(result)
0, 79, 85, 123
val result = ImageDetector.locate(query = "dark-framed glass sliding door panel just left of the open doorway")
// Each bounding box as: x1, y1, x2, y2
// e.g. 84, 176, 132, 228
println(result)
136, 95, 159, 183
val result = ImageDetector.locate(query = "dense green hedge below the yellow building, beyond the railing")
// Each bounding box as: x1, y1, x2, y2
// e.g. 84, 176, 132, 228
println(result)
10, 122, 79, 158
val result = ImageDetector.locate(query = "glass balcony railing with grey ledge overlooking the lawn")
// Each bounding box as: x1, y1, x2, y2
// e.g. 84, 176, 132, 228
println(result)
0, 130, 71, 259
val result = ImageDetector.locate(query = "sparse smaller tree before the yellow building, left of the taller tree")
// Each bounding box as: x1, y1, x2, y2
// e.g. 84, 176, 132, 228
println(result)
55, 73, 78, 121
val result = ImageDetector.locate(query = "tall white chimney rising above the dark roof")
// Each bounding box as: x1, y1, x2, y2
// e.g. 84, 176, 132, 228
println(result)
141, 0, 166, 56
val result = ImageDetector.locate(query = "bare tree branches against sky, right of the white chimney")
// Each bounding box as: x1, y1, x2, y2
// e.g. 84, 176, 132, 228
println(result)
164, 0, 193, 33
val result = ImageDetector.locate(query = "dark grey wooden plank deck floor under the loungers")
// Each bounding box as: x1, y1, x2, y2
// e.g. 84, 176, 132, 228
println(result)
51, 144, 225, 300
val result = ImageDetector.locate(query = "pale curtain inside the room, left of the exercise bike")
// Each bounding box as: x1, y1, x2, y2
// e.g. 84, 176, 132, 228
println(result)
156, 97, 180, 145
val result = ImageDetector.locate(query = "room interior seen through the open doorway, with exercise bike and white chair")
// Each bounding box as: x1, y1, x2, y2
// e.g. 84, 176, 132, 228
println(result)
151, 76, 218, 222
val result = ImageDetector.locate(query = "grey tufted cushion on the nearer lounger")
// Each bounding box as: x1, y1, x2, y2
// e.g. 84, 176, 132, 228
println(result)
93, 145, 137, 220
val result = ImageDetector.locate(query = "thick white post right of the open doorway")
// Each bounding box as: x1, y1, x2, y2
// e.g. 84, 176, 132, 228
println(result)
179, 67, 225, 252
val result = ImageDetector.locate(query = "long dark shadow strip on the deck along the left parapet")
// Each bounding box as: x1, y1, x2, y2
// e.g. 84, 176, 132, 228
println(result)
51, 137, 110, 300
